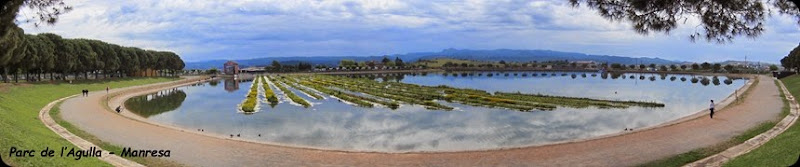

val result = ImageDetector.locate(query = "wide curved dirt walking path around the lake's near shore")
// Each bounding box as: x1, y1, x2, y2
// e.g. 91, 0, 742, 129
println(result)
56, 76, 783, 166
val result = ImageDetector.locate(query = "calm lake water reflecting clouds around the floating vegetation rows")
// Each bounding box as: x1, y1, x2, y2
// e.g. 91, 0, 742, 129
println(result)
123, 72, 746, 152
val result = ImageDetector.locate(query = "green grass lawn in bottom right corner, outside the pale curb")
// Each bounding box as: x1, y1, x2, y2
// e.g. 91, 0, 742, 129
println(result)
725, 75, 800, 166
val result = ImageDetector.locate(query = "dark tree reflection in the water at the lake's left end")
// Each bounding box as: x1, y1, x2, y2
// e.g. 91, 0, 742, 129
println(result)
125, 88, 186, 118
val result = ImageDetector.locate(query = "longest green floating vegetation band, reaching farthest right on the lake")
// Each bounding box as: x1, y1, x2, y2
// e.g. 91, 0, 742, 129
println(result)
298, 75, 664, 111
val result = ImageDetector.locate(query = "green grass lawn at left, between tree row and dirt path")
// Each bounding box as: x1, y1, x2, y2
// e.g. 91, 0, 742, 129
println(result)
0, 78, 176, 166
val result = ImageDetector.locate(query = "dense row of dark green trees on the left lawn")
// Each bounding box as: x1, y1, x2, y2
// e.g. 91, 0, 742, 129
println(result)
0, 27, 185, 82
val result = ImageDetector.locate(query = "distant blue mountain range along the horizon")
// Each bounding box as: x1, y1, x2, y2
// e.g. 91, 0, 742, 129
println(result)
186, 49, 685, 69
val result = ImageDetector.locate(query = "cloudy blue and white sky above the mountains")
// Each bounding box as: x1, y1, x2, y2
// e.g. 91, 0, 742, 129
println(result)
14, 0, 800, 63
